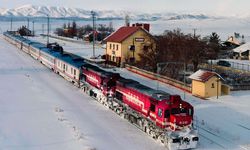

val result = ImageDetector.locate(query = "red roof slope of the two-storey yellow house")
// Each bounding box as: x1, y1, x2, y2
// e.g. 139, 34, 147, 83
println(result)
104, 27, 142, 43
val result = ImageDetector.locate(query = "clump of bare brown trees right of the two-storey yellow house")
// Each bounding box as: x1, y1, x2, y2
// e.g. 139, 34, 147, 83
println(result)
135, 29, 221, 78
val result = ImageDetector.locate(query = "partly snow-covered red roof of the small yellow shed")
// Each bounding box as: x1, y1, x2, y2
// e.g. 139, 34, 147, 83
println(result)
189, 70, 223, 82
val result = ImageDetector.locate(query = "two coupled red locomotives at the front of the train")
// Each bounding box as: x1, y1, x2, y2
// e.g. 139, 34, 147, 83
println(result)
82, 67, 198, 149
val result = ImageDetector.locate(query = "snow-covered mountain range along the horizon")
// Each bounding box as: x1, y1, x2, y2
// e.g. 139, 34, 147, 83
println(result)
0, 5, 215, 21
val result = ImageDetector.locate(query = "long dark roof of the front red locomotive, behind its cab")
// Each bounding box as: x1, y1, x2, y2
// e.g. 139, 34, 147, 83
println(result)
117, 78, 170, 101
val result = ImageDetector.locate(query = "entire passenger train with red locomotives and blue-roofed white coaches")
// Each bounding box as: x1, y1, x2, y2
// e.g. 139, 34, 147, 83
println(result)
4, 31, 199, 150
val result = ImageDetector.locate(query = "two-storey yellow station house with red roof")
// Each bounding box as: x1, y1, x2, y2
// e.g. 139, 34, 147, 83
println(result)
104, 24, 155, 66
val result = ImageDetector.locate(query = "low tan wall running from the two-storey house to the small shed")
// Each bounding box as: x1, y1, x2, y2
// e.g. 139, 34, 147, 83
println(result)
125, 64, 192, 93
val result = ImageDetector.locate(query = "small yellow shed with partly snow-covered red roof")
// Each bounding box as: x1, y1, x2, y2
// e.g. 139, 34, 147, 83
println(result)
189, 70, 229, 98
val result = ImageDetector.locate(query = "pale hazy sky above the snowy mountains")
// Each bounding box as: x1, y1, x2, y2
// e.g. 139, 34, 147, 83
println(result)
0, 0, 250, 15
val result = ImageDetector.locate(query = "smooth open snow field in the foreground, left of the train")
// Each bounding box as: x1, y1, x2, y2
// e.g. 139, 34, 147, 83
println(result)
0, 35, 168, 150
